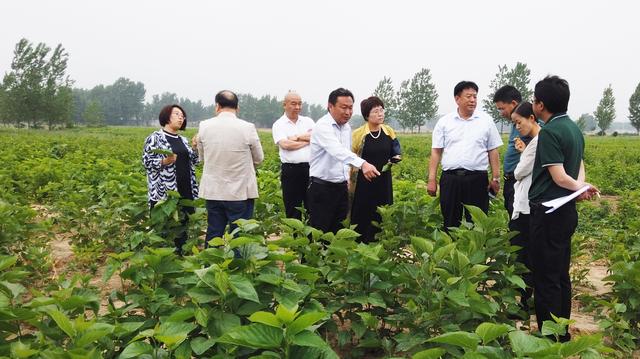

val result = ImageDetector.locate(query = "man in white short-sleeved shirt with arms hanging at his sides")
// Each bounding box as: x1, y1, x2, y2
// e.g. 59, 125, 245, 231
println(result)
427, 81, 502, 230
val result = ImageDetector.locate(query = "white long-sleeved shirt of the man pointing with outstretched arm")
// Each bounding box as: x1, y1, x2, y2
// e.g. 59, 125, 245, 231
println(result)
309, 113, 365, 183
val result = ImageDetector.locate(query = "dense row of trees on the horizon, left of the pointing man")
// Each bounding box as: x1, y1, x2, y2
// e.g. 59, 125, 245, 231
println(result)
0, 39, 326, 129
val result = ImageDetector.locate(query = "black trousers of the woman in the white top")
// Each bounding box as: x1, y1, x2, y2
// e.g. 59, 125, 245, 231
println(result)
509, 213, 534, 310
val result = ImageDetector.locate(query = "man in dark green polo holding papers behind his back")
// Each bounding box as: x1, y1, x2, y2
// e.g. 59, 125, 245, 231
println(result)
529, 76, 598, 341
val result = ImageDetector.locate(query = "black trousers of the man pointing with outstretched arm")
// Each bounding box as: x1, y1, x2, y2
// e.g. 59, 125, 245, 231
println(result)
307, 178, 349, 233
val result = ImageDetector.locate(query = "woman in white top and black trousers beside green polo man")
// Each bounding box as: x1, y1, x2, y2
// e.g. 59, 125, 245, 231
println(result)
509, 102, 540, 317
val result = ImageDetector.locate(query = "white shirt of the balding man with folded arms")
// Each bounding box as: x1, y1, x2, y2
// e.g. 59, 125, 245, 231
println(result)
271, 114, 315, 163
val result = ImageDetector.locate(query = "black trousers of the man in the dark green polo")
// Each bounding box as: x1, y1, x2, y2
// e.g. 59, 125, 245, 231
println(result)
529, 201, 578, 341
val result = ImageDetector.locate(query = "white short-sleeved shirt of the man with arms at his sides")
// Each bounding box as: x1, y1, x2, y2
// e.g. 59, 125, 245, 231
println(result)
431, 110, 502, 171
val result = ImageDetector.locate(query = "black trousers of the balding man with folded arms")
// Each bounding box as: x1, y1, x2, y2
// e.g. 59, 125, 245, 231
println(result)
280, 162, 309, 219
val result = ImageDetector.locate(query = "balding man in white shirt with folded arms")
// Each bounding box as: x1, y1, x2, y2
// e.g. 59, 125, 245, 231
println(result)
271, 91, 314, 219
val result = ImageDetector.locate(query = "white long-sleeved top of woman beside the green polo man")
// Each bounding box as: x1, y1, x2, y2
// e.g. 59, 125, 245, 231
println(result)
511, 136, 538, 219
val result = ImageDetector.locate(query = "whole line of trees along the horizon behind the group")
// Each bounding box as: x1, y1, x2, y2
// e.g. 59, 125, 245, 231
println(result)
0, 39, 640, 134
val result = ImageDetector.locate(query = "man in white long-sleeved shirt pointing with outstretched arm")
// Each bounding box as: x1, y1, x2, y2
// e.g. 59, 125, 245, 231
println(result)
307, 88, 380, 233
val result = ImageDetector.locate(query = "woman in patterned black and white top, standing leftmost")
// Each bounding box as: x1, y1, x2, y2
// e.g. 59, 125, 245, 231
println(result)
142, 104, 198, 253
